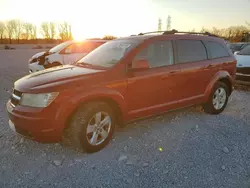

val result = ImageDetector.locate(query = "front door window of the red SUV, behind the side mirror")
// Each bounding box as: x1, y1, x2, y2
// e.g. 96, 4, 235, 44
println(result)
135, 41, 174, 68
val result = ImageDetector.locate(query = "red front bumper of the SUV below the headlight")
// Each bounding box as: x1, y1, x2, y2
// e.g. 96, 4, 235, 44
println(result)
6, 101, 64, 143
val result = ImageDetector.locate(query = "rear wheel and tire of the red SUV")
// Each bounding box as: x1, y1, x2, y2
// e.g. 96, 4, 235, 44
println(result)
204, 82, 229, 114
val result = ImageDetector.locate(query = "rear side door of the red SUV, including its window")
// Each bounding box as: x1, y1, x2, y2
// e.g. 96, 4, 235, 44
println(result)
176, 39, 210, 105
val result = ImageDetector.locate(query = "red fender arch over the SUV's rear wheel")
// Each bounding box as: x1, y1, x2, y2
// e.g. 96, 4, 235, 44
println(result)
205, 71, 233, 101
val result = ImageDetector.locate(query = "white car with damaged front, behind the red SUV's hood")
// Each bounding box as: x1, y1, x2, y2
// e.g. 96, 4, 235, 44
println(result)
29, 40, 106, 73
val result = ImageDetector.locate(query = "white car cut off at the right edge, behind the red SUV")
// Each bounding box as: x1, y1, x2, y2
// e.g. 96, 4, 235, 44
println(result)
235, 45, 250, 85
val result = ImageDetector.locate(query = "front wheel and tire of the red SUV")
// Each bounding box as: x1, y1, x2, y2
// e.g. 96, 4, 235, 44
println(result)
63, 102, 115, 153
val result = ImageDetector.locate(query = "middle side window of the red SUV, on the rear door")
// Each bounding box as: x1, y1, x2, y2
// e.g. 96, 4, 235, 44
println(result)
176, 40, 207, 63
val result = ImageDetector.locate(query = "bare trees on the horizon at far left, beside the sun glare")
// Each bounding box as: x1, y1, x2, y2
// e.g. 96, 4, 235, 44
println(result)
0, 19, 73, 44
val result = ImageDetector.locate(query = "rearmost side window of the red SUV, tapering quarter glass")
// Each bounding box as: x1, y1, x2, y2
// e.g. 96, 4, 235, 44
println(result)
205, 41, 229, 59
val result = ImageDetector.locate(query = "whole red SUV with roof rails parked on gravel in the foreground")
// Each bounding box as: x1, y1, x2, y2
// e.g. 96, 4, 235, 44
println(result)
7, 30, 236, 152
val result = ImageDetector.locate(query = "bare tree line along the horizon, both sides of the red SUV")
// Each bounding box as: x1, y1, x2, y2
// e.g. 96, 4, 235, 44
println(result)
0, 19, 250, 44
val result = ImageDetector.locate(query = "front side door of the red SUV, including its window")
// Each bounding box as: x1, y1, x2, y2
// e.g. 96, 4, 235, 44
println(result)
128, 41, 180, 118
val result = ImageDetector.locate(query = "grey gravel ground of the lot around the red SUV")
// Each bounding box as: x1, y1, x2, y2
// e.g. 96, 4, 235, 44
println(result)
0, 50, 250, 188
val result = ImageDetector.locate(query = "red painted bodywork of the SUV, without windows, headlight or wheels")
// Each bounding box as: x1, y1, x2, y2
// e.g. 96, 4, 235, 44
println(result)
7, 35, 236, 140
